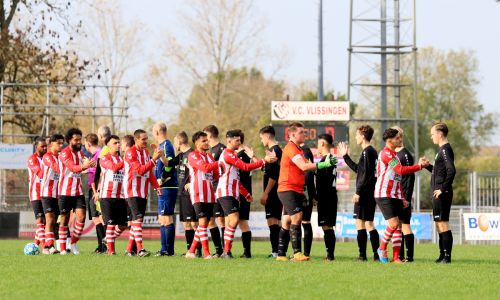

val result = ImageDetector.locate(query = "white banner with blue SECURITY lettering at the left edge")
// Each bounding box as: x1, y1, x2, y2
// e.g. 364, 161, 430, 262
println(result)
0, 144, 33, 170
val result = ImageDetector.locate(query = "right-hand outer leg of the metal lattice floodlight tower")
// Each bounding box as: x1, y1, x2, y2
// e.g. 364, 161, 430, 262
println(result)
412, 0, 421, 211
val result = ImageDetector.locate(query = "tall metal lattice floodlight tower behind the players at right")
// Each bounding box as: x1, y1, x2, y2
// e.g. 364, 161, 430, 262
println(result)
347, 0, 420, 210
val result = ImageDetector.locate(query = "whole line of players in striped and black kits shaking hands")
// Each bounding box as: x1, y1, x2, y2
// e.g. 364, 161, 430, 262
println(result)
28, 123, 454, 263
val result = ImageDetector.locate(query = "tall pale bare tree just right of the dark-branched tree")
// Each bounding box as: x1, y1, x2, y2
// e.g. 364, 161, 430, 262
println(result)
80, 0, 143, 132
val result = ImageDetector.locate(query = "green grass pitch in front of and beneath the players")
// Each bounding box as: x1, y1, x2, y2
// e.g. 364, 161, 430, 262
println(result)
0, 240, 500, 299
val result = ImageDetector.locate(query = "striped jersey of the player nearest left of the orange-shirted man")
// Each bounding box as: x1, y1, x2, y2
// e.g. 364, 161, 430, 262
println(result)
217, 148, 265, 199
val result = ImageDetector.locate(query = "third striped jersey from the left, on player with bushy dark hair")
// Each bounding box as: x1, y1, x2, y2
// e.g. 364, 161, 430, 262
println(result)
59, 146, 84, 196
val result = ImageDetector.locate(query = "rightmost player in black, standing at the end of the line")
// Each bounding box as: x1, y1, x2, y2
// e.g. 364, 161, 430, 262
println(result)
427, 122, 456, 264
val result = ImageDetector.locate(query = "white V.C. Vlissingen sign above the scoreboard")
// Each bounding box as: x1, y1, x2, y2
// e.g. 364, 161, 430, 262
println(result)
271, 101, 349, 121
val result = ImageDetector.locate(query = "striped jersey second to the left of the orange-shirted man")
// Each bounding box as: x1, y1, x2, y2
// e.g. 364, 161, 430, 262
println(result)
188, 150, 219, 203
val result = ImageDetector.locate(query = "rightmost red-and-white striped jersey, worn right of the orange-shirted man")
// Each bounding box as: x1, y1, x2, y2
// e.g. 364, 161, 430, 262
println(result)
375, 147, 421, 200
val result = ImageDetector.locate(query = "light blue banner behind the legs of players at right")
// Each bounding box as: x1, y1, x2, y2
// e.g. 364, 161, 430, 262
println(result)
335, 212, 432, 240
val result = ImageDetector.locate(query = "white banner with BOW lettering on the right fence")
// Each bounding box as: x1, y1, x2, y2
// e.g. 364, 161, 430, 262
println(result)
464, 213, 500, 241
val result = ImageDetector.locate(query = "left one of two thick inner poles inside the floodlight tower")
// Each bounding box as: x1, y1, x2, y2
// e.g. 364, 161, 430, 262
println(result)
380, 0, 388, 149
